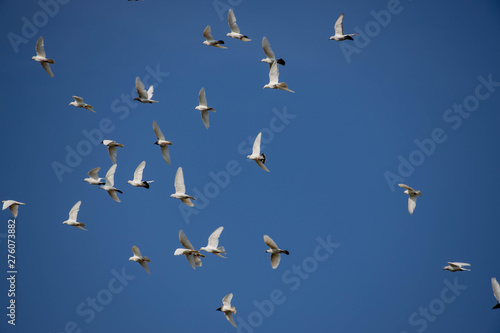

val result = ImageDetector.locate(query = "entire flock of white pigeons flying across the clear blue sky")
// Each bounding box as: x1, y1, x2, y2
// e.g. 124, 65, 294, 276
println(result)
2, 6, 500, 327
